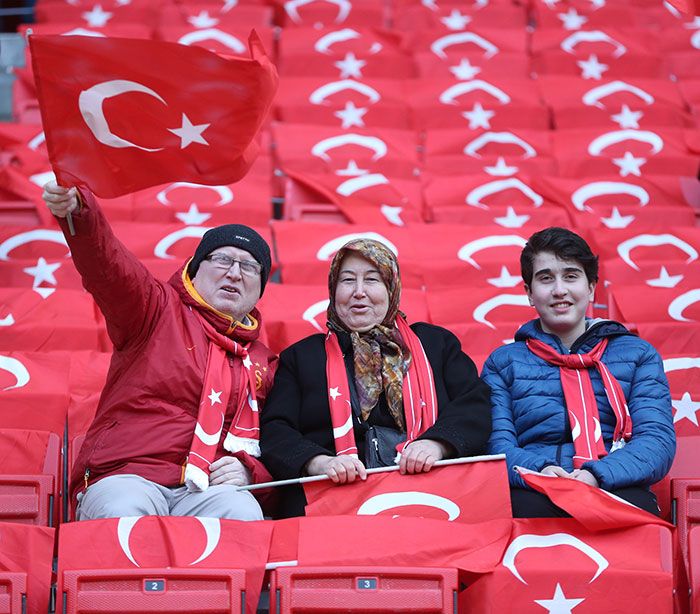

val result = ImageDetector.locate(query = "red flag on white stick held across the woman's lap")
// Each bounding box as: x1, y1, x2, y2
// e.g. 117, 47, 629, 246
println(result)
304, 460, 512, 524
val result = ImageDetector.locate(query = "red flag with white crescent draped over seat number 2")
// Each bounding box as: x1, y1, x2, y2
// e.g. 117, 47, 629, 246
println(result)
58, 516, 272, 614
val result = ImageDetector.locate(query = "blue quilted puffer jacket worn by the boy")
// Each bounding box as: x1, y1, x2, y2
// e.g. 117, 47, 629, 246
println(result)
482, 320, 676, 490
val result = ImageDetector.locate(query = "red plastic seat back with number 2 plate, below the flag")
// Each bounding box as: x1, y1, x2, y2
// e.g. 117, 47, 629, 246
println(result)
63, 568, 245, 614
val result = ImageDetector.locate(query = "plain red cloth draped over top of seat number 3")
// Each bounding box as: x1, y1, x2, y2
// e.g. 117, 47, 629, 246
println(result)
292, 516, 513, 576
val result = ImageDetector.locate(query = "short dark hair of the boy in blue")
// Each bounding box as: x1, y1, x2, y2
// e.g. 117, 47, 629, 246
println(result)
520, 226, 598, 286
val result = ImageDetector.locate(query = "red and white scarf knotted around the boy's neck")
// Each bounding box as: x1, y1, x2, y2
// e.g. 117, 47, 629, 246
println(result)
527, 339, 632, 469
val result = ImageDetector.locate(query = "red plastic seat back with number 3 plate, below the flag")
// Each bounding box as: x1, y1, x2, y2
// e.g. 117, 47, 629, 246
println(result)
270, 567, 458, 614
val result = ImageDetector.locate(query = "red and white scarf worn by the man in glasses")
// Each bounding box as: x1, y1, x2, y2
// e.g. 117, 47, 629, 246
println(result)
185, 316, 260, 491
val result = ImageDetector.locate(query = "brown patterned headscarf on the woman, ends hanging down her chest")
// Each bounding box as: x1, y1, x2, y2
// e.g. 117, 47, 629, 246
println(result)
327, 239, 411, 431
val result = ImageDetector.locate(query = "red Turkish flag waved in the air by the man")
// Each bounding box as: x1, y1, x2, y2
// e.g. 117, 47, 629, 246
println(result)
30, 32, 277, 197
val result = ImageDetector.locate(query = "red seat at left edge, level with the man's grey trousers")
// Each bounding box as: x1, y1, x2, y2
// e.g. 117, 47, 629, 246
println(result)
0, 429, 61, 526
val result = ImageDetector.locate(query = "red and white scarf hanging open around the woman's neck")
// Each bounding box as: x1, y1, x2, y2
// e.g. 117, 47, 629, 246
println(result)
326, 316, 437, 458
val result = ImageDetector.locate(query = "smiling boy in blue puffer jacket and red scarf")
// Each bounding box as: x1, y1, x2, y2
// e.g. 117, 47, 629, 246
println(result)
482, 228, 676, 518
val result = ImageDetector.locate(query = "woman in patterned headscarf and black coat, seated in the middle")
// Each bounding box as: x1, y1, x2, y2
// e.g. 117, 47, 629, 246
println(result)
260, 239, 491, 517
